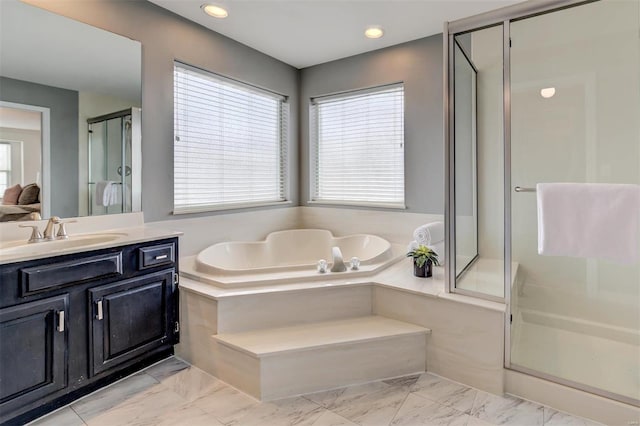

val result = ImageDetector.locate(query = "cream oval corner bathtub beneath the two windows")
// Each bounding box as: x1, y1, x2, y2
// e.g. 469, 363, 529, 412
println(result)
181, 229, 399, 287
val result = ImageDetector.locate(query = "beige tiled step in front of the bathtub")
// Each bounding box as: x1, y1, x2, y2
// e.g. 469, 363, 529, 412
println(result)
212, 315, 431, 400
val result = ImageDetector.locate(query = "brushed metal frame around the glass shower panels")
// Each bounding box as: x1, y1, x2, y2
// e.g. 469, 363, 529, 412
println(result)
443, 0, 638, 406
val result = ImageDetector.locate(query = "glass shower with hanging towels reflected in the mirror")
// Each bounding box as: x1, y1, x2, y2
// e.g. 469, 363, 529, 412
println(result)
87, 108, 142, 216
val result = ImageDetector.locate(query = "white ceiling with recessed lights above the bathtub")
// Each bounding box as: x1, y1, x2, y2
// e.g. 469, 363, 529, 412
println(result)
149, 0, 520, 68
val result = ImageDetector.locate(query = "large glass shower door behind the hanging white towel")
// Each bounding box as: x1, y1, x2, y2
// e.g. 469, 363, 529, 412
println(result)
508, 0, 640, 404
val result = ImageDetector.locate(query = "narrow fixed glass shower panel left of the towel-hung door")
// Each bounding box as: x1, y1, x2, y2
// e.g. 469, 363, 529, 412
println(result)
450, 25, 504, 300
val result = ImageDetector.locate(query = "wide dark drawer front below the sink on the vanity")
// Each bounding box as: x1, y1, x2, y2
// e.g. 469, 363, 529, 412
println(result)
19, 252, 123, 297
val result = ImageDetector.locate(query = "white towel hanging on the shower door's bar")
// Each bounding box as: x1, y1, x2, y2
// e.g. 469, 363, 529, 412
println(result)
536, 183, 640, 263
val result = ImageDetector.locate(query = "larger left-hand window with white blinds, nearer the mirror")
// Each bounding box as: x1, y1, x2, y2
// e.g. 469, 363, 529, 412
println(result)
174, 63, 289, 213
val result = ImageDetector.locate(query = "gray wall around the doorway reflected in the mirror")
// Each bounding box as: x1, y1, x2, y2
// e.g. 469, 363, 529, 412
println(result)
0, 77, 78, 217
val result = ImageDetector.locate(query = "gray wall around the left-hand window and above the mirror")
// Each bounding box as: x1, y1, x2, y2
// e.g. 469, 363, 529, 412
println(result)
27, 0, 299, 222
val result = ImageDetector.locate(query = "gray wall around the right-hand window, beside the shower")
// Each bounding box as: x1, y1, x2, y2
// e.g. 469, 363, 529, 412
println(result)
300, 35, 444, 214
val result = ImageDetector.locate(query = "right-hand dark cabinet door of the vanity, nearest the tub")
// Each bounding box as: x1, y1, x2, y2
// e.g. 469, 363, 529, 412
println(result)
89, 269, 176, 376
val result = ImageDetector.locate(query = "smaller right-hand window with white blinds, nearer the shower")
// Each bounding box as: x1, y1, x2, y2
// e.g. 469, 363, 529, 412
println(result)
311, 84, 404, 208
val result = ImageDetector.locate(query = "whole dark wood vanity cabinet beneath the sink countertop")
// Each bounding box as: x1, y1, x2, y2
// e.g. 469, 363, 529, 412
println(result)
0, 238, 179, 425
